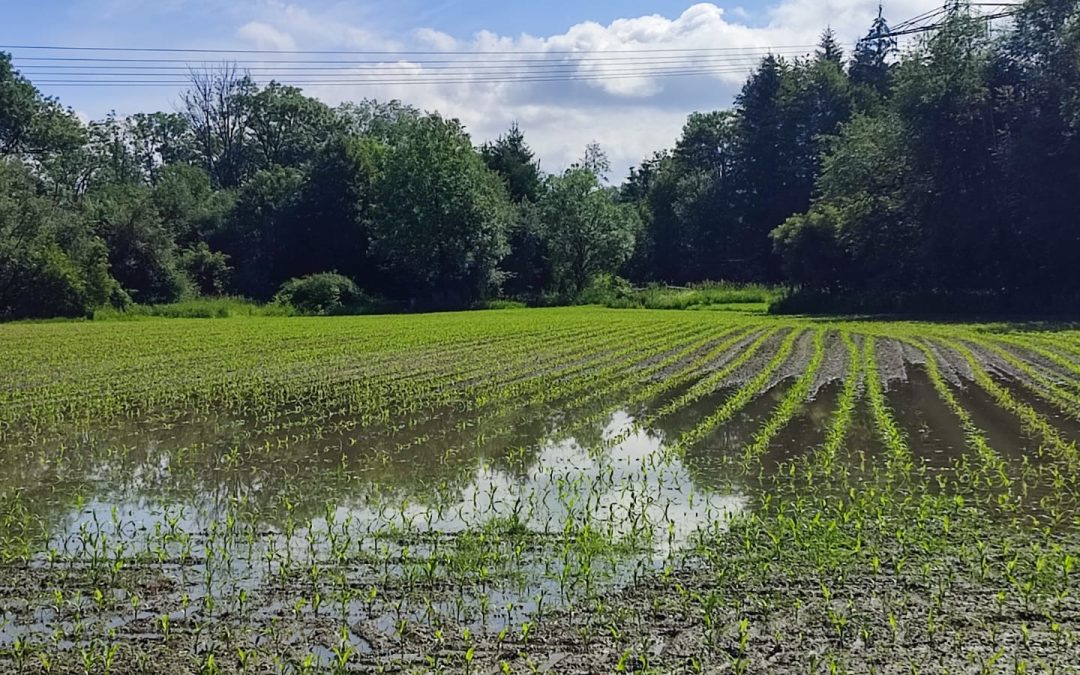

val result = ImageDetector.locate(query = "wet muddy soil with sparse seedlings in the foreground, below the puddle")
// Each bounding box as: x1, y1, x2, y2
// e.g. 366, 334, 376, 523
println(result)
0, 527, 1080, 675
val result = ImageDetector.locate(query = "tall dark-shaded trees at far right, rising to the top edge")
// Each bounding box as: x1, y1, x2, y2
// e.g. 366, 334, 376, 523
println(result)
773, 1, 1080, 312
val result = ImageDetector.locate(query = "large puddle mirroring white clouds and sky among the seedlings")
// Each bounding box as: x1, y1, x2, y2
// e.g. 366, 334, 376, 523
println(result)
0, 410, 748, 647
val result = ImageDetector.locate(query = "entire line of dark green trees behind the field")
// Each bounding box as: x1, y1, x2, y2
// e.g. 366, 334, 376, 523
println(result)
0, 0, 1080, 319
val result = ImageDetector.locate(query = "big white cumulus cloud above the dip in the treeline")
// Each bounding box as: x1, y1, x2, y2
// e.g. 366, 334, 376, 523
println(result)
291, 0, 940, 173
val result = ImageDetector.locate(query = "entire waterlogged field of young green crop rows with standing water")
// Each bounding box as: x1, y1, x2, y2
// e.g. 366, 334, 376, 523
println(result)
0, 309, 1080, 673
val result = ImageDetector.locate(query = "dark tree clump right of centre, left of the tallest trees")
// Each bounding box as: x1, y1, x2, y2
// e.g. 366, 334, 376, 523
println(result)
624, 33, 853, 283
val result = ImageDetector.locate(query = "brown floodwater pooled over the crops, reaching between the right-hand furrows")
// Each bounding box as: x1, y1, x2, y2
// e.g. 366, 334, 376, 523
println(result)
0, 368, 1080, 649
